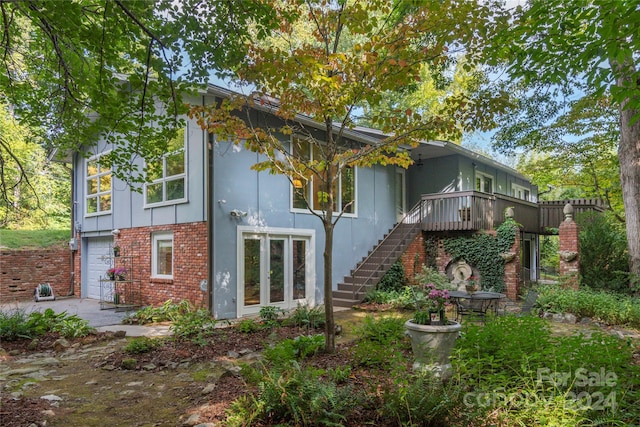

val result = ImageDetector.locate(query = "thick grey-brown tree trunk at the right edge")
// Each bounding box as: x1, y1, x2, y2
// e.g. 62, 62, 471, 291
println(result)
617, 64, 640, 286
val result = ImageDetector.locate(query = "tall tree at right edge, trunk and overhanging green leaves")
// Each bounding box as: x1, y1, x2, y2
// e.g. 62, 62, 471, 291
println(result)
492, 0, 640, 284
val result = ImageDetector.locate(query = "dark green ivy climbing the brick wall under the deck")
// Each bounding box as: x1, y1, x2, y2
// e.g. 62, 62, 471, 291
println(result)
444, 218, 519, 292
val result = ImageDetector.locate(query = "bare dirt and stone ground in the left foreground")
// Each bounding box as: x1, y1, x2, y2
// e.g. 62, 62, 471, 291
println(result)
0, 311, 380, 427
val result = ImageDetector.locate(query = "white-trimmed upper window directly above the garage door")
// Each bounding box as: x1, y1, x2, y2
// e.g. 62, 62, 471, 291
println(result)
84, 155, 111, 216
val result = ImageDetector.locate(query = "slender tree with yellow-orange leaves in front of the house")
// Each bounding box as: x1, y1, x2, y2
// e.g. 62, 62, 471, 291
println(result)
191, 0, 499, 351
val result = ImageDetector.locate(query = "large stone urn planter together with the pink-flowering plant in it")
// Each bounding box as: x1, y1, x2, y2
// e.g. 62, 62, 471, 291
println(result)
404, 283, 462, 376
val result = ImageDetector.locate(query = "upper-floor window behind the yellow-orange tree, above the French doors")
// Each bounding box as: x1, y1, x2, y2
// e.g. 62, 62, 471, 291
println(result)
291, 137, 357, 216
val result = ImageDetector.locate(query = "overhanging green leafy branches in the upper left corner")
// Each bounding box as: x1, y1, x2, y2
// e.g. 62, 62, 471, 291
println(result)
0, 0, 276, 189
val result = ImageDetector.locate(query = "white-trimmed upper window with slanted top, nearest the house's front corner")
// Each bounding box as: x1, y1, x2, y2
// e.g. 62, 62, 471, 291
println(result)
144, 129, 187, 207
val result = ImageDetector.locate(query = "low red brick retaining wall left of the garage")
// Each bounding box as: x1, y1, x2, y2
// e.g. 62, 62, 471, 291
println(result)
0, 249, 71, 303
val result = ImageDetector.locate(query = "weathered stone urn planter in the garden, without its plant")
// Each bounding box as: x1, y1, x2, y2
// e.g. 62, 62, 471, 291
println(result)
404, 319, 462, 377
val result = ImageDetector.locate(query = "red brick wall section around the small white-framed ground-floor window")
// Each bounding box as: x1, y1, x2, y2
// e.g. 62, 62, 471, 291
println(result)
114, 222, 207, 307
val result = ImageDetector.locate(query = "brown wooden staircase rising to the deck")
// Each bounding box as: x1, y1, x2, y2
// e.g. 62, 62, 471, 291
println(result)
333, 209, 420, 307
